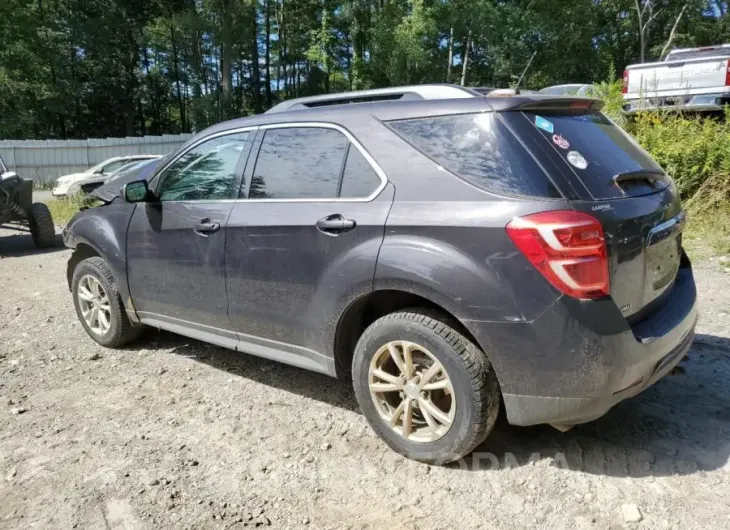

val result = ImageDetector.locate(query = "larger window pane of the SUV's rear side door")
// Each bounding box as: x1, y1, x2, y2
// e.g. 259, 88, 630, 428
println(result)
248, 127, 348, 199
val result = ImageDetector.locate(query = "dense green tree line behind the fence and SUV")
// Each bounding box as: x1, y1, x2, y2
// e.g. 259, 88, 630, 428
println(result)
0, 0, 730, 139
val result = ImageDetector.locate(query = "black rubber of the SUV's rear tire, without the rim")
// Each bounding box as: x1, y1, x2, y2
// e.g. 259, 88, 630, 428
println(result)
352, 309, 501, 464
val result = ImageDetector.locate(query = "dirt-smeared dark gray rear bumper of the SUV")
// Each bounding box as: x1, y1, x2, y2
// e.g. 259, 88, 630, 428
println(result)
470, 268, 697, 425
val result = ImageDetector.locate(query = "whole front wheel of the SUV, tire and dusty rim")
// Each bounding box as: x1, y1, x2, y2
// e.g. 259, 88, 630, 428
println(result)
71, 256, 142, 348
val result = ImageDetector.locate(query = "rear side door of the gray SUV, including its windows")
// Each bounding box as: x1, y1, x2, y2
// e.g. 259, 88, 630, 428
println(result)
226, 124, 393, 371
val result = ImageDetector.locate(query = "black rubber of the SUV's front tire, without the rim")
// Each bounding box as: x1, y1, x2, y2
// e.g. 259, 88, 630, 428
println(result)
71, 256, 144, 348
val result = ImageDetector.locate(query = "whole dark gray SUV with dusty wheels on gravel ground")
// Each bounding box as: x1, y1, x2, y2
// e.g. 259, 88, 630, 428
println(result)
64, 86, 697, 463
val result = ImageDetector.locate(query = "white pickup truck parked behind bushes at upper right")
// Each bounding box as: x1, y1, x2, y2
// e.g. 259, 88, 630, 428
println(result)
623, 44, 730, 114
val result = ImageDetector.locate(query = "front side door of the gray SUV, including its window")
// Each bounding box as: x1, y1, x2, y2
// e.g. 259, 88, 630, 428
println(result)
127, 130, 254, 346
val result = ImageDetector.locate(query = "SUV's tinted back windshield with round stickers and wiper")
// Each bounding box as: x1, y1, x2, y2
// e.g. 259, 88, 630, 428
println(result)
505, 111, 669, 199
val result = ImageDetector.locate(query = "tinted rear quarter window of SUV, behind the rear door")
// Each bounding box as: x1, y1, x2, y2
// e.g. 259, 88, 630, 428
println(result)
389, 113, 560, 198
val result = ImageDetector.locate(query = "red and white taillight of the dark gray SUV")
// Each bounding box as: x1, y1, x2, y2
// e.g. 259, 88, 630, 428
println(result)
506, 211, 610, 298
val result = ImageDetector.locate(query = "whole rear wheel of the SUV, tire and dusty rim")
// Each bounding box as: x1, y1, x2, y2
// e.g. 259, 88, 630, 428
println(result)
352, 310, 500, 464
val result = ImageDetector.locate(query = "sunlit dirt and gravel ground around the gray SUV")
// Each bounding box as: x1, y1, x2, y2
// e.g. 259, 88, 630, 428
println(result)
0, 228, 730, 529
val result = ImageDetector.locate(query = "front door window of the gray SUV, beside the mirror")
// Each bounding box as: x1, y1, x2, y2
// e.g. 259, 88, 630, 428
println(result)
158, 132, 249, 201
